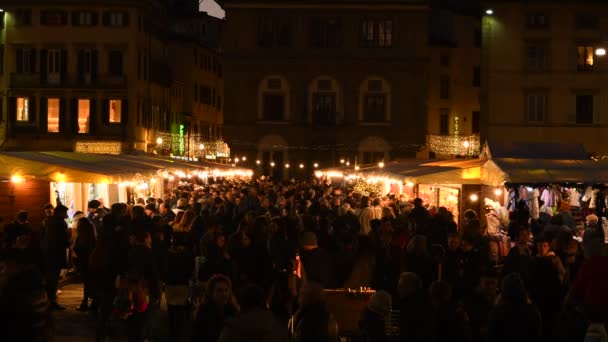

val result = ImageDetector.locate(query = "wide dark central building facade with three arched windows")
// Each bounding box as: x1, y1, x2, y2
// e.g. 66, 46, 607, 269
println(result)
222, 0, 429, 176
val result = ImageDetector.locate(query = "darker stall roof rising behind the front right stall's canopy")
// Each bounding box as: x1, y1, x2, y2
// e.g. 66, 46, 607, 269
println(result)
481, 141, 590, 160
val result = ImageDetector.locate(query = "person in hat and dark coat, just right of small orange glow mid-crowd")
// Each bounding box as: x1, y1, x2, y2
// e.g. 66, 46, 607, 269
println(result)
300, 231, 335, 289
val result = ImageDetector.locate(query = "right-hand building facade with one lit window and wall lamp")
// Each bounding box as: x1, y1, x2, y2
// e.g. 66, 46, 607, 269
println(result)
482, 0, 608, 155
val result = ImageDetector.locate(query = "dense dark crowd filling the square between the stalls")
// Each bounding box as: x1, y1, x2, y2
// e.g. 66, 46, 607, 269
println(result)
0, 179, 608, 342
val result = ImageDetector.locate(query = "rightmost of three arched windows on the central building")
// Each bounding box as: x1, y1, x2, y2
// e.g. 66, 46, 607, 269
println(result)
359, 77, 391, 123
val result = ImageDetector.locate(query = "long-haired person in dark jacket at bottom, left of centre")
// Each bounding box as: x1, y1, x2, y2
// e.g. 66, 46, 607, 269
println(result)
192, 274, 238, 342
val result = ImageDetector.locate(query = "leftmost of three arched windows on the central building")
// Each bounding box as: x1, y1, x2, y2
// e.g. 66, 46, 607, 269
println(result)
258, 76, 290, 121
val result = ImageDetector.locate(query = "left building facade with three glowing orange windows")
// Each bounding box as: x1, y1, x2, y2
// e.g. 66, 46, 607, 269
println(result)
0, 0, 221, 157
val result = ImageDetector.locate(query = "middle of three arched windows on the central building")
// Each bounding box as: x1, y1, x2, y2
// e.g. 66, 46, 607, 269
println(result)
308, 76, 342, 125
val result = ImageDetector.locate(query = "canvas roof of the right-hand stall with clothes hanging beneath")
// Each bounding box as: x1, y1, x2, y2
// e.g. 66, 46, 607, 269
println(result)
481, 158, 608, 186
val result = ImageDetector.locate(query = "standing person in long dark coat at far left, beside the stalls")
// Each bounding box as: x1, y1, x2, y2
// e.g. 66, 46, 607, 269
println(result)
42, 204, 69, 310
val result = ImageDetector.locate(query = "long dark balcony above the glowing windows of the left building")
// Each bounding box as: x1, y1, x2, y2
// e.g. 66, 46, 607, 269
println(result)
10, 73, 127, 89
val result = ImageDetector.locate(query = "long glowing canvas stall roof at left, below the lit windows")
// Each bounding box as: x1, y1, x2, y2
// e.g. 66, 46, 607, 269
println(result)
0, 152, 162, 183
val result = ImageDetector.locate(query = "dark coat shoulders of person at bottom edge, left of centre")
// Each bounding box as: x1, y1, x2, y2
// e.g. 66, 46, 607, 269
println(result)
218, 309, 287, 342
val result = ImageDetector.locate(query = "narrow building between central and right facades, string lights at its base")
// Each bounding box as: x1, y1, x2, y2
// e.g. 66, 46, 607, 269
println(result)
427, 1, 481, 158
